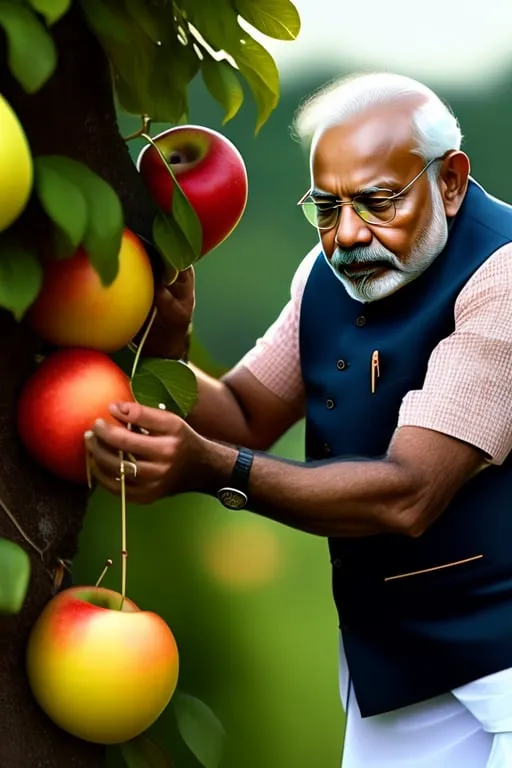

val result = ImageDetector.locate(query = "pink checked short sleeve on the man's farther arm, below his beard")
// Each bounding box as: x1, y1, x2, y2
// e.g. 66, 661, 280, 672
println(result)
230, 246, 319, 411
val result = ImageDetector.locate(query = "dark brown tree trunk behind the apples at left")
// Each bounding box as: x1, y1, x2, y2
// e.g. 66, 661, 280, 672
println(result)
0, 5, 154, 768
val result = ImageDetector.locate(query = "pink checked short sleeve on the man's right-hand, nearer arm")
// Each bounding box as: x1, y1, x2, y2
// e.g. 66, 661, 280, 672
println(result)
398, 243, 512, 465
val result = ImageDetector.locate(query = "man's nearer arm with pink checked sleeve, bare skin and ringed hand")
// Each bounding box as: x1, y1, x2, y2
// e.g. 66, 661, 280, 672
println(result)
90, 244, 512, 536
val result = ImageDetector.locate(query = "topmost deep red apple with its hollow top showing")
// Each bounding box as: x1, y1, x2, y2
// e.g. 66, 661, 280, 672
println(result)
137, 125, 248, 256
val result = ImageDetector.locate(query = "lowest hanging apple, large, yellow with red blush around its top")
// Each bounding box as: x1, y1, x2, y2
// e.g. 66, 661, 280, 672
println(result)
26, 586, 179, 744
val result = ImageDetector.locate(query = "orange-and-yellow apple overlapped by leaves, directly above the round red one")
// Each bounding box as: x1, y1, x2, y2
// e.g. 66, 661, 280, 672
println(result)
28, 228, 154, 352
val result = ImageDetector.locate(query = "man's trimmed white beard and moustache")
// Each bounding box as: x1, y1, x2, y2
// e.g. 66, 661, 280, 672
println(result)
324, 178, 448, 303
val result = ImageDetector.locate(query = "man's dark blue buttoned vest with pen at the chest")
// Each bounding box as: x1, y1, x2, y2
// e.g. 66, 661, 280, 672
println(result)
300, 181, 512, 717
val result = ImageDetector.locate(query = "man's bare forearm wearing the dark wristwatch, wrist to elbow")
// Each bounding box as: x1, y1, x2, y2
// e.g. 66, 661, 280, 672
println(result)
200, 446, 412, 537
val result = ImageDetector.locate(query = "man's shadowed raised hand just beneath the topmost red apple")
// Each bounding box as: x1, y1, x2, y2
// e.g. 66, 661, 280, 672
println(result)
136, 267, 195, 360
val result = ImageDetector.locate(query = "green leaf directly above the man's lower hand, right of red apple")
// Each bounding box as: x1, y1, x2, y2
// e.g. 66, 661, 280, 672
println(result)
132, 357, 197, 418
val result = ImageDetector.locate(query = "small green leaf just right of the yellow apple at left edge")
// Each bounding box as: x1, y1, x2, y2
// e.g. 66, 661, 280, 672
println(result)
34, 156, 87, 249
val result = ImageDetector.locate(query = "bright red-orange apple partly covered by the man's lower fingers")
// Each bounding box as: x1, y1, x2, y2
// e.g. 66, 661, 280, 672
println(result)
17, 349, 134, 483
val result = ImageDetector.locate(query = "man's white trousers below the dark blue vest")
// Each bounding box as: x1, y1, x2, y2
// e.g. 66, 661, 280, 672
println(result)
340, 639, 512, 768
